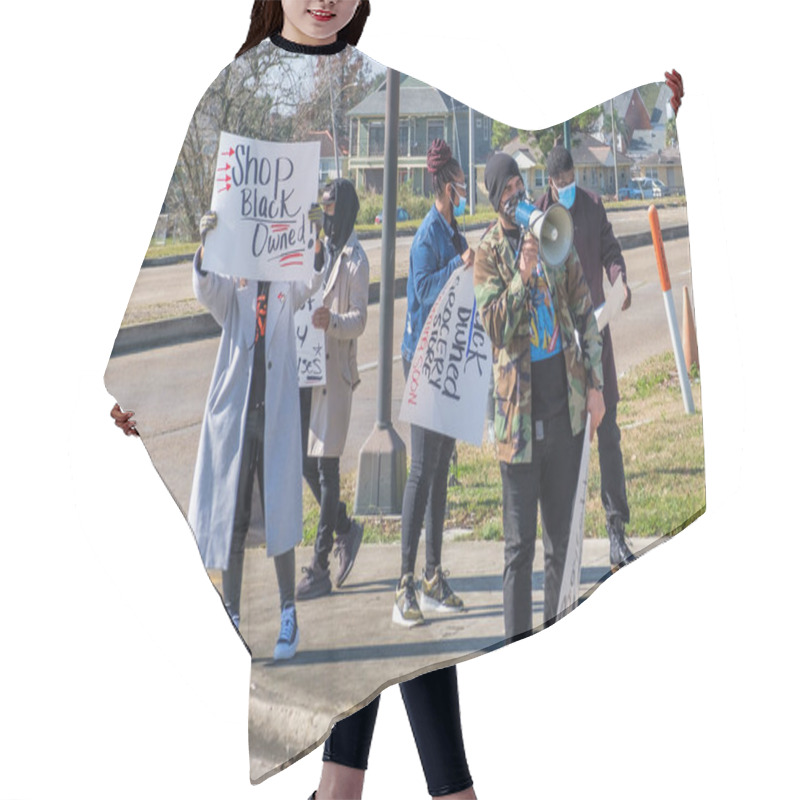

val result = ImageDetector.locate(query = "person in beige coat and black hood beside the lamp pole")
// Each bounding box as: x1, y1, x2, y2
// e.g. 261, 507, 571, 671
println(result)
297, 178, 369, 600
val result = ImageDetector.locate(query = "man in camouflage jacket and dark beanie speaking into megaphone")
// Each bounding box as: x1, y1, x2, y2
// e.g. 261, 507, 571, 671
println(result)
474, 153, 604, 638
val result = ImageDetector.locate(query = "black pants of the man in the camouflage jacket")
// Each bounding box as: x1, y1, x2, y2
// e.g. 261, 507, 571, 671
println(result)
500, 410, 582, 638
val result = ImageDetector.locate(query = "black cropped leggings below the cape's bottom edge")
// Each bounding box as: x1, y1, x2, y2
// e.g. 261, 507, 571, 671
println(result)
322, 667, 472, 797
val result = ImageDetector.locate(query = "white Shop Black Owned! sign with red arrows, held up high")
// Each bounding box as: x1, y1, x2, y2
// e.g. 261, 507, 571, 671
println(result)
203, 131, 319, 281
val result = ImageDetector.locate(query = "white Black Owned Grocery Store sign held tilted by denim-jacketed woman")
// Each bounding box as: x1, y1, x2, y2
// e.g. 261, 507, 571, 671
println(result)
400, 267, 492, 445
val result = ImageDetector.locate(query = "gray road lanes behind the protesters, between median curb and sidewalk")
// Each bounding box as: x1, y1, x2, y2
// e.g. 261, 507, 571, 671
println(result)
106, 231, 691, 527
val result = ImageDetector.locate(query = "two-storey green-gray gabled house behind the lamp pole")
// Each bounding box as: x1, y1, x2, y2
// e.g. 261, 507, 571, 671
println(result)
347, 75, 492, 195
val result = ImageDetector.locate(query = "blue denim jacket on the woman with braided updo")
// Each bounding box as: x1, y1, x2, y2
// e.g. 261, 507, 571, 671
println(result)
402, 205, 467, 361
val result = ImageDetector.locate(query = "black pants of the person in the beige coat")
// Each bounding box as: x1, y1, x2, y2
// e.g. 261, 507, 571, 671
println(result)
300, 386, 350, 567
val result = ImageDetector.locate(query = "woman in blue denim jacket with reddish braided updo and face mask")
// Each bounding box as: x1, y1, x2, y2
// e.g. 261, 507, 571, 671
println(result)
392, 139, 475, 627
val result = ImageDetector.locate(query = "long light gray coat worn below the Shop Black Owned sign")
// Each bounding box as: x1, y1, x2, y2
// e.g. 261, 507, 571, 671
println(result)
189, 251, 322, 569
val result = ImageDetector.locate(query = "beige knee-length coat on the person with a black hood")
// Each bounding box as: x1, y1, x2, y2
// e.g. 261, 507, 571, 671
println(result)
308, 231, 369, 458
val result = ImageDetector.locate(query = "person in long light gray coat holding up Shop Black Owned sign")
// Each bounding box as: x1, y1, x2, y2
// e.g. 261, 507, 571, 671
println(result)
189, 212, 323, 660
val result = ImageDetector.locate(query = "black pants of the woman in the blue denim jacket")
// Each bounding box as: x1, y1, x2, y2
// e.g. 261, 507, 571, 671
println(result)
400, 359, 456, 575
